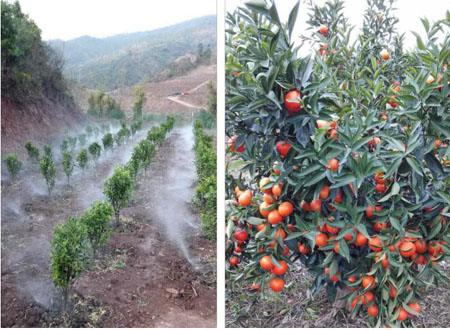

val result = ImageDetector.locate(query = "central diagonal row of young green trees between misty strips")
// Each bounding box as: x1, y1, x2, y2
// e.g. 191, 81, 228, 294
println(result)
46, 117, 174, 309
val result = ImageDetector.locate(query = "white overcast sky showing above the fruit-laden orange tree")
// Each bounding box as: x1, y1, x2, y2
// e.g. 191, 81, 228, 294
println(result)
226, 0, 450, 48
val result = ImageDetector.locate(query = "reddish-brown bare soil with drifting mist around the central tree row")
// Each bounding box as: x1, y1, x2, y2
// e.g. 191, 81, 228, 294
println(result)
2, 124, 216, 327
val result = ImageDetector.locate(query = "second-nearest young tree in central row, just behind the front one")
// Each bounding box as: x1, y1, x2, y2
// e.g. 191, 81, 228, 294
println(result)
80, 202, 113, 258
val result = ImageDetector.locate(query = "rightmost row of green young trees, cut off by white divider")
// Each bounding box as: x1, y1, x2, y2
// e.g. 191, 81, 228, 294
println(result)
193, 120, 217, 240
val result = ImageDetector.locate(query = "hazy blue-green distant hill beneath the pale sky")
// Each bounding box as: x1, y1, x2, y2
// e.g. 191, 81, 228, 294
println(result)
48, 15, 216, 91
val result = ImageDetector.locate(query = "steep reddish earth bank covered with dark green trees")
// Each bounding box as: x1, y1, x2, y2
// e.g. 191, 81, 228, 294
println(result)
1, 1, 84, 153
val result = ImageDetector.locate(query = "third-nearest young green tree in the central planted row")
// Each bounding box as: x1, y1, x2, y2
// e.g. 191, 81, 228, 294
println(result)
103, 167, 133, 227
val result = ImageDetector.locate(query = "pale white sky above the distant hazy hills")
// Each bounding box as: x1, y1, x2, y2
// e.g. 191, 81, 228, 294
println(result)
13, 0, 216, 40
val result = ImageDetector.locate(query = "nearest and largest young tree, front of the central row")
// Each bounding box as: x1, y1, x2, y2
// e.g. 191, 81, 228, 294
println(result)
50, 217, 86, 310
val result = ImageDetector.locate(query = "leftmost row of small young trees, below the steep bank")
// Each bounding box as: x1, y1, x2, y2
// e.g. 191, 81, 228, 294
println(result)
5, 121, 142, 195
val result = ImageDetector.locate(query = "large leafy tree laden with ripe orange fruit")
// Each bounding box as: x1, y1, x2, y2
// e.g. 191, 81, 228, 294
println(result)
226, 0, 450, 326
